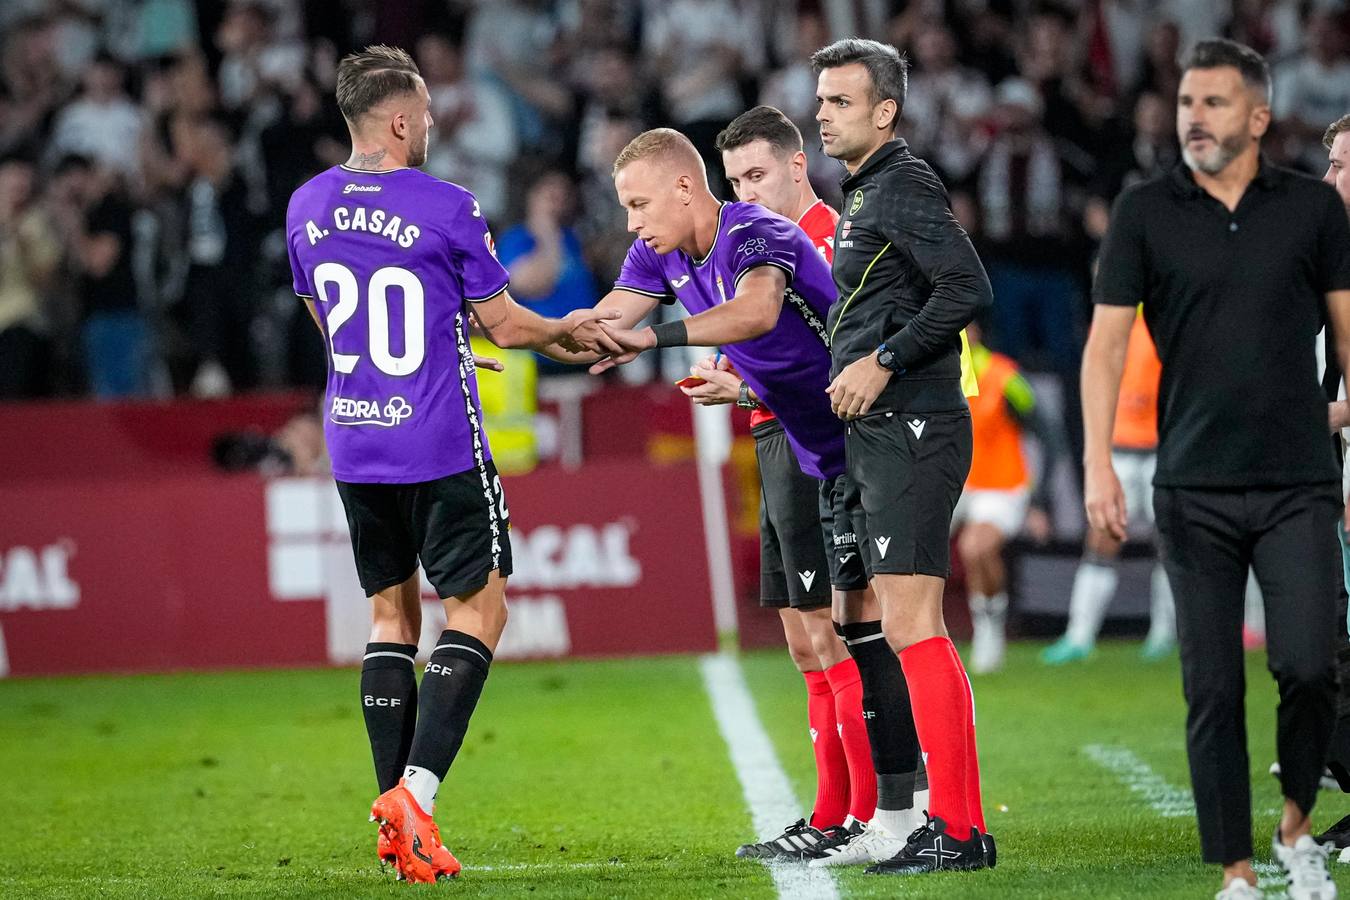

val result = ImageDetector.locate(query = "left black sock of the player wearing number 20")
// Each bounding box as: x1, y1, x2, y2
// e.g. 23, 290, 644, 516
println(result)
360, 644, 417, 793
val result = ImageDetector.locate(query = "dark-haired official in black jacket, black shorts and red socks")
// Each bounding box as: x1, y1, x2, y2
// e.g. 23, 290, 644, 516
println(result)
811, 38, 996, 874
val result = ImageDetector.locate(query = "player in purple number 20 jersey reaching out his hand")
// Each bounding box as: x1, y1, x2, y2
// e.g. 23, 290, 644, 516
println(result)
286, 46, 616, 881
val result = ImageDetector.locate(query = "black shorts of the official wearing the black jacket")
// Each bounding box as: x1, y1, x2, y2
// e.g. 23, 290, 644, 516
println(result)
844, 410, 972, 578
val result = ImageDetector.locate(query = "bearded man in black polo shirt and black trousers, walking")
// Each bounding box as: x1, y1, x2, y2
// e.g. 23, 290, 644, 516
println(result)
1083, 40, 1350, 900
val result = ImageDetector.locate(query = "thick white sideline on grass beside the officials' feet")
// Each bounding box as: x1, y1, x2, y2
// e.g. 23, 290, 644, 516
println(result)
699, 653, 840, 900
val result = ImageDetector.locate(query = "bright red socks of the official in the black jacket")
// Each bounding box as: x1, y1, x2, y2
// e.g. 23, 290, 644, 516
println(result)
900, 637, 973, 841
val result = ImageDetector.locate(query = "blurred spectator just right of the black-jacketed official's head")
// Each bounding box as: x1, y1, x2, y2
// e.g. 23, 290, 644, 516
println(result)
907, 23, 992, 186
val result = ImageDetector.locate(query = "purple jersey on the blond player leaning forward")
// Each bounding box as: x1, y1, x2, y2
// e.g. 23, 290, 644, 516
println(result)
614, 202, 844, 478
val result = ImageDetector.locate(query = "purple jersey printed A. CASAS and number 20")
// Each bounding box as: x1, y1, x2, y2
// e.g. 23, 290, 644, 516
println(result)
286, 166, 508, 484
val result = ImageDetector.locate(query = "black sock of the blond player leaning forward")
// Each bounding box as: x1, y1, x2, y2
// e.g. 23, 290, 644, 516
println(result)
840, 622, 927, 810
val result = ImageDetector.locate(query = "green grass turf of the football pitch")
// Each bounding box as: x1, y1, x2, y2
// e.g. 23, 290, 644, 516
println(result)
0, 645, 1350, 897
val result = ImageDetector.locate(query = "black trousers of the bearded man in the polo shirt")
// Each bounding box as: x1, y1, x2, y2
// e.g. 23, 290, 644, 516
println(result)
1153, 484, 1342, 865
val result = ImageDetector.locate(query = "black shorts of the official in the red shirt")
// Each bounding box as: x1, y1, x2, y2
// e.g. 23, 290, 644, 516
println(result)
752, 420, 830, 610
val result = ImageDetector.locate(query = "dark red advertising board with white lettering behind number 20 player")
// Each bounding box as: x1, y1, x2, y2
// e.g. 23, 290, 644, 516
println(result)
0, 463, 717, 675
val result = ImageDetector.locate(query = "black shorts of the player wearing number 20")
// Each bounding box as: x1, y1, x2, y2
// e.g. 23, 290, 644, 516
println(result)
338, 460, 512, 598
